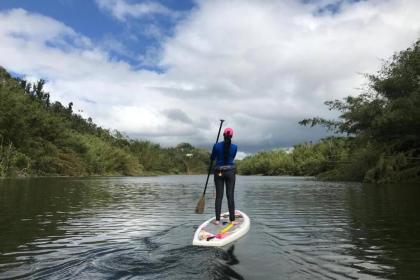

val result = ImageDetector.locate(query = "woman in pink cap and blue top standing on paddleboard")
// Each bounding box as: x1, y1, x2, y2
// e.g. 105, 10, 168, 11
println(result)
211, 128, 238, 224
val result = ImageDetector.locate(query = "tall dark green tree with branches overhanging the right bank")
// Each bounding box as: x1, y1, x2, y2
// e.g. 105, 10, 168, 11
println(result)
300, 41, 420, 182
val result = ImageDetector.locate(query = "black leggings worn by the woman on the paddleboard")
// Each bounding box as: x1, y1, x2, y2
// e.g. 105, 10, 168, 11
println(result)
214, 169, 236, 221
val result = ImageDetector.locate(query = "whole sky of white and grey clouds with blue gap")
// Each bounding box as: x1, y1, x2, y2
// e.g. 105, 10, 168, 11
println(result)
0, 0, 420, 153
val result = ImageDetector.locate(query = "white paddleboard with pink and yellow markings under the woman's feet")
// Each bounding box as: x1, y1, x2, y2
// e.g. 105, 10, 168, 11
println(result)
193, 210, 251, 247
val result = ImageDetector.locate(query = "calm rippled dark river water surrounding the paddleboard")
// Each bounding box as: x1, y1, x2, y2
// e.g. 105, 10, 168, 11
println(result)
0, 176, 420, 279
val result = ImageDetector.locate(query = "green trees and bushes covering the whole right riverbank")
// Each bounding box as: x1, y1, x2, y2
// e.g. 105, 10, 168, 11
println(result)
239, 41, 420, 183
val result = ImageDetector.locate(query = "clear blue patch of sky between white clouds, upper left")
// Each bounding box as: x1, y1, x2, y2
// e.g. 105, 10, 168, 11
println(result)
0, 0, 195, 73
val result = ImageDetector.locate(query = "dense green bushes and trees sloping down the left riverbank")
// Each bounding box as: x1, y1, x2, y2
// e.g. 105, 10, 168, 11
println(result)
0, 67, 209, 177
